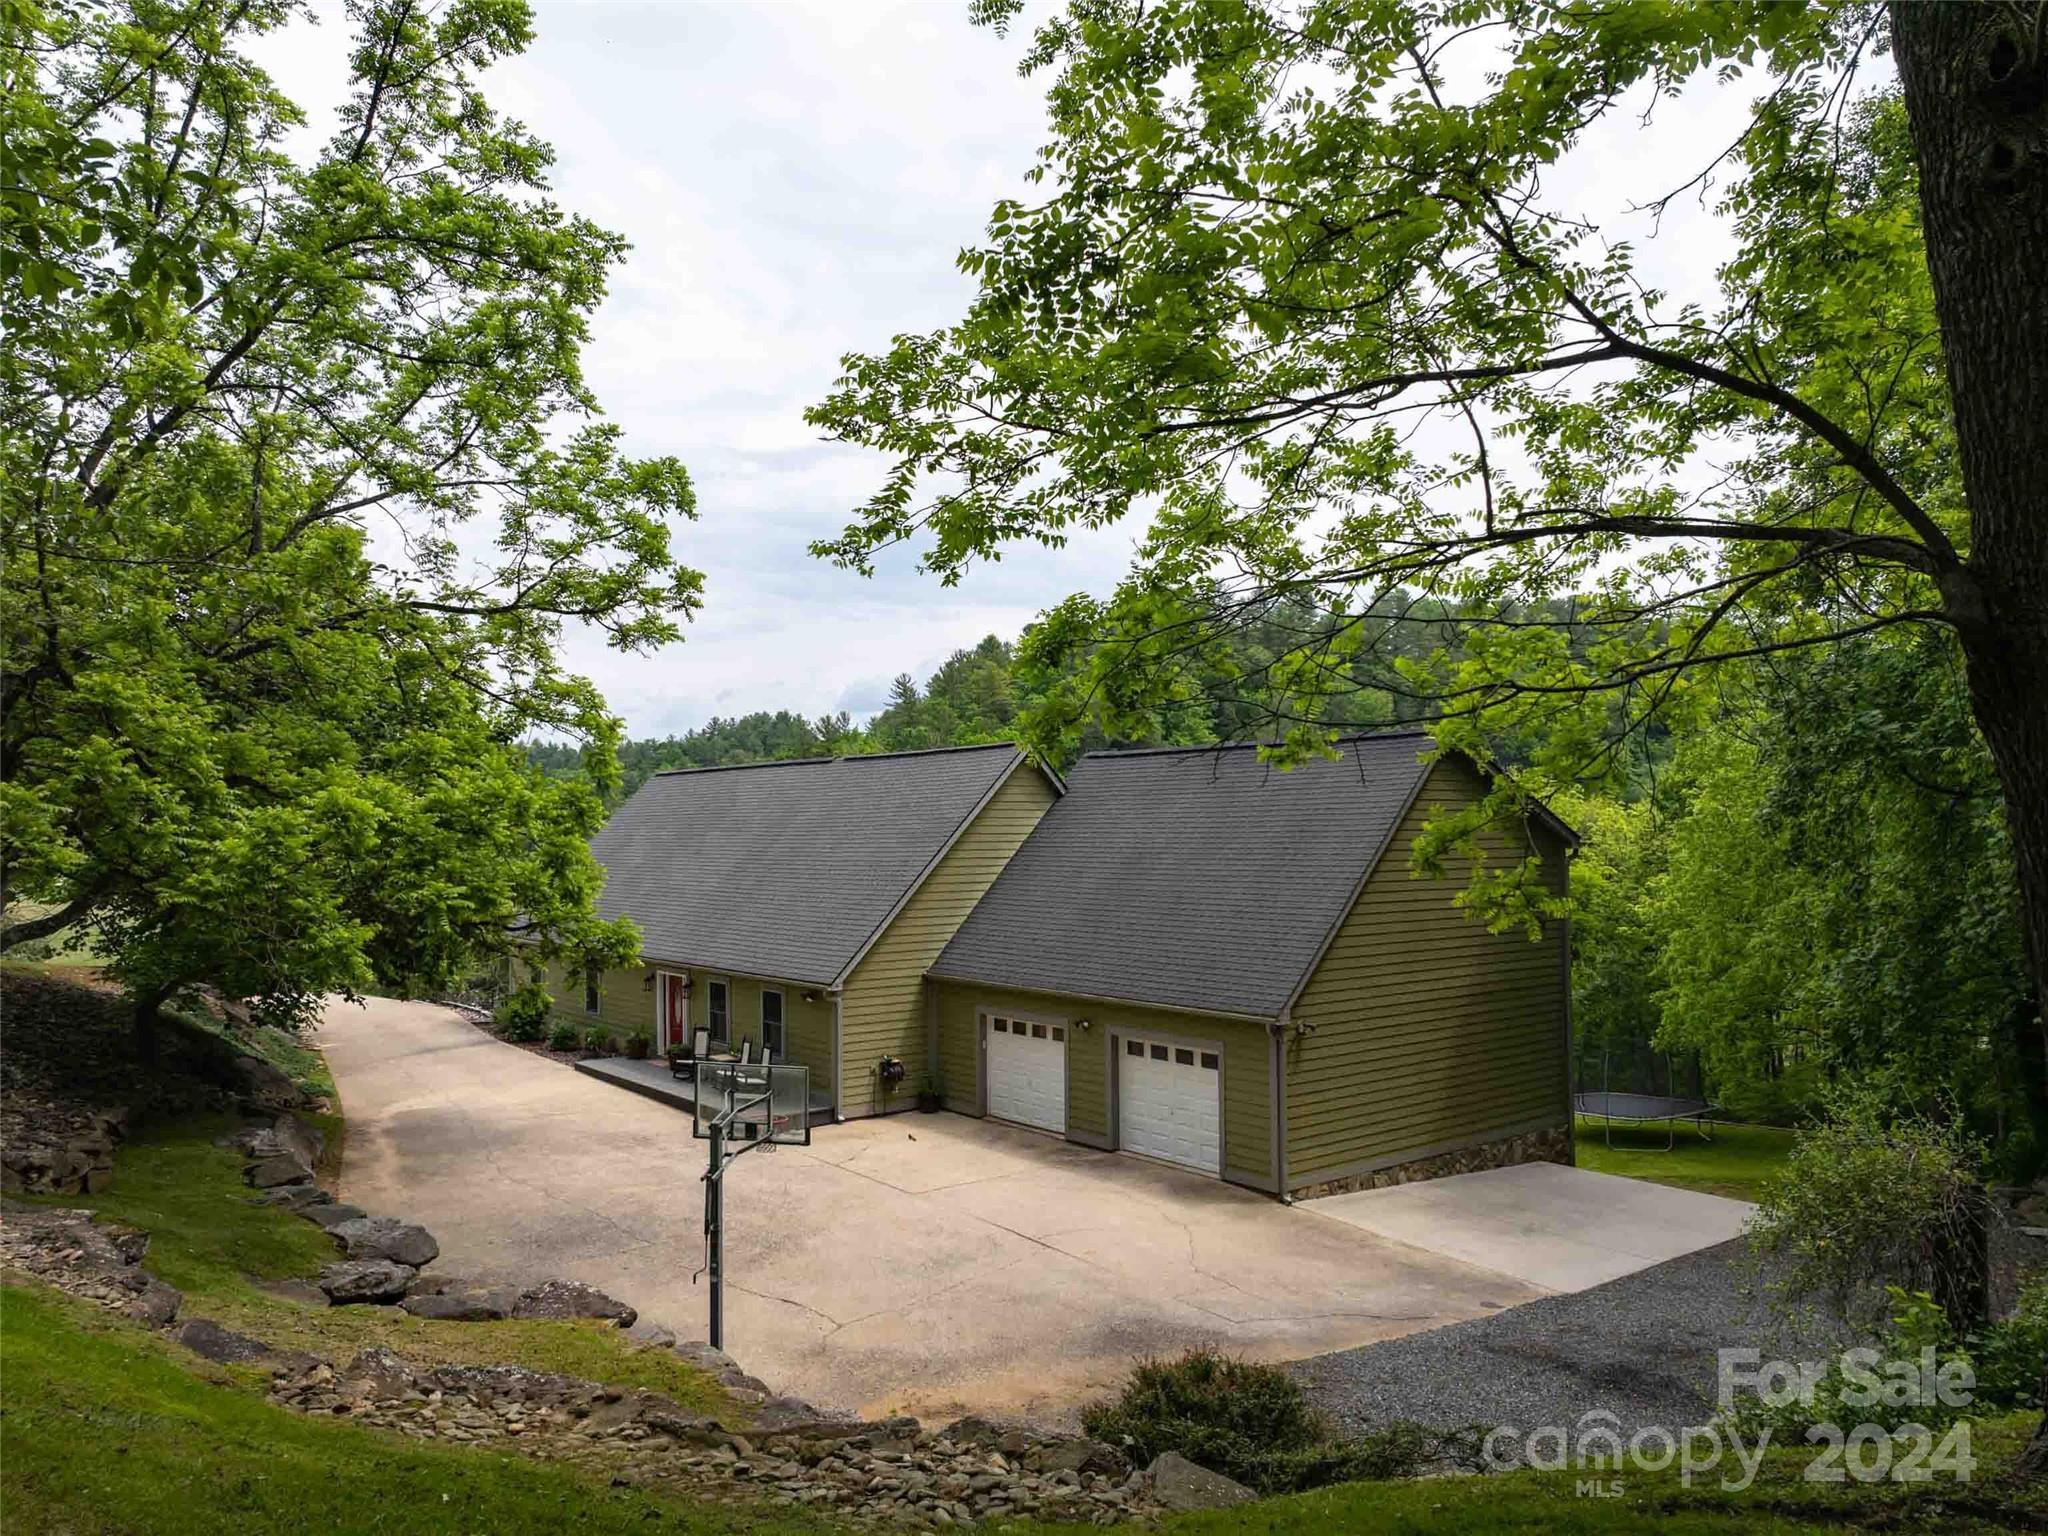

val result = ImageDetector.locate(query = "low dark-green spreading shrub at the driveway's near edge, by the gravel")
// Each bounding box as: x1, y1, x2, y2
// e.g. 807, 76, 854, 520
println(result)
1081, 1350, 1438, 1493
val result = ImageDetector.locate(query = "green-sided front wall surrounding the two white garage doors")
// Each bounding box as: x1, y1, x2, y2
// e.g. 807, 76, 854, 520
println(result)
932, 981, 1274, 1188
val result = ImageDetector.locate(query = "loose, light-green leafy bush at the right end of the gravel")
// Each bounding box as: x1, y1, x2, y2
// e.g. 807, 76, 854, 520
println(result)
1749, 1092, 1989, 1333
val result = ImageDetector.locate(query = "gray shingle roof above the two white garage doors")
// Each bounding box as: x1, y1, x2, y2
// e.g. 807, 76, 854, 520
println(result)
932, 735, 1430, 1018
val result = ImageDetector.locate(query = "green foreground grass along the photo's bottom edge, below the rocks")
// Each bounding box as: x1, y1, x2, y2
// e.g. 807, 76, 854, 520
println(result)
0, 1286, 2048, 1536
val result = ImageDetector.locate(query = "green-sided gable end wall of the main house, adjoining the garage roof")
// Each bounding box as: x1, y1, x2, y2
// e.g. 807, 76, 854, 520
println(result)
840, 762, 1053, 1118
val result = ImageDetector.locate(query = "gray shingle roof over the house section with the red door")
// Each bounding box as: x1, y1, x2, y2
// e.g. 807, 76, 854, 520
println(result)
590, 743, 1040, 983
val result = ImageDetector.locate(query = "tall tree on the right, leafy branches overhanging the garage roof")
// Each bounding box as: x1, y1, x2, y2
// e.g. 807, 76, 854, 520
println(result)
811, 0, 2048, 1097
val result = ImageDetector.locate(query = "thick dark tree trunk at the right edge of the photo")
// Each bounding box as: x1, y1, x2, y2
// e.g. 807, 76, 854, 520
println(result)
1890, 0, 2048, 1477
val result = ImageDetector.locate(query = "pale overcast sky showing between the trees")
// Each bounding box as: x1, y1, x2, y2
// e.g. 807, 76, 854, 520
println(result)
262, 0, 1810, 735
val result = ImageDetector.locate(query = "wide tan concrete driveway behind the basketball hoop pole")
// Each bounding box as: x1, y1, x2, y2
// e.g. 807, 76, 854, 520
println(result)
319, 999, 1544, 1421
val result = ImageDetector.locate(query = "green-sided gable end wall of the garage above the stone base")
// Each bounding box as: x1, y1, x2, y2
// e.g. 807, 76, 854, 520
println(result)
1286, 758, 1569, 1188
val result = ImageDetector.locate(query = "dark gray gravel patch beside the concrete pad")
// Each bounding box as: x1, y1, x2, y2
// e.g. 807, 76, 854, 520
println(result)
1292, 1241, 1837, 1436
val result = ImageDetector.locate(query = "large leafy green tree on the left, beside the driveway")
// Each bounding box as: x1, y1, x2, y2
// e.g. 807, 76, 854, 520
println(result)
0, 0, 698, 1036
